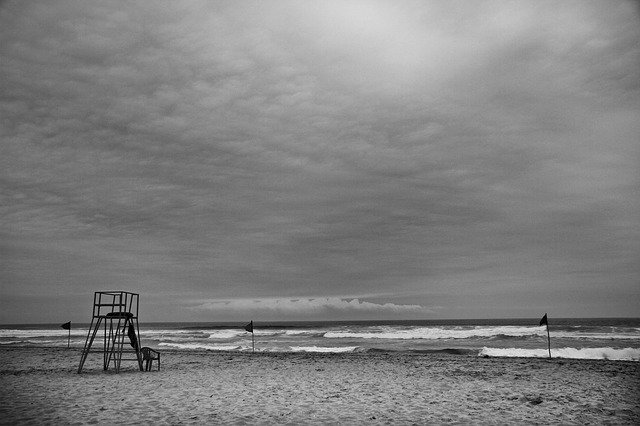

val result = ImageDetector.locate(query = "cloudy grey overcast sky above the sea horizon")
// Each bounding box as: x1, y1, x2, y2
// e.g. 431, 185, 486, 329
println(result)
0, 0, 640, 323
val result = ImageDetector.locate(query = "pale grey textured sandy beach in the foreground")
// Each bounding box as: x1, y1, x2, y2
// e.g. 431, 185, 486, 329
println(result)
0, 348, 640, 424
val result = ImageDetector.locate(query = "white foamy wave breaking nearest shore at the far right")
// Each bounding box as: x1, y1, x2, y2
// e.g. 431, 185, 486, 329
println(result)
478, 347, 640, 361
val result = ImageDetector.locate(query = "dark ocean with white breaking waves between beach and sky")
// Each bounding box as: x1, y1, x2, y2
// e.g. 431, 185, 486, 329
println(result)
0, 318, 640, 361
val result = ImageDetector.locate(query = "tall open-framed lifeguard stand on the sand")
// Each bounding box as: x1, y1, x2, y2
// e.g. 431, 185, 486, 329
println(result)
78, 291, 143, 373
